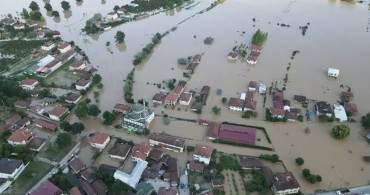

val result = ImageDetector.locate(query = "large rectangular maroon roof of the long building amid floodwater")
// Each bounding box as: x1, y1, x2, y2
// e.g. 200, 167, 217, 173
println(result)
218, 124, 256, 144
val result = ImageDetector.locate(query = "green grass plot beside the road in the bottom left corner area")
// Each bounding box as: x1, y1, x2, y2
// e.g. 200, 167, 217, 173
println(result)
12, 161, 53, 194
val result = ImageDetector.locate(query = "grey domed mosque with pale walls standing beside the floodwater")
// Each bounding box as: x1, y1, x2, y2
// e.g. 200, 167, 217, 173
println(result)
122, 104, 154, 132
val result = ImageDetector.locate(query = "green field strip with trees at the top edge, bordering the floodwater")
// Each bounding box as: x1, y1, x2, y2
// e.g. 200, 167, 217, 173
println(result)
123, 0, 184, 13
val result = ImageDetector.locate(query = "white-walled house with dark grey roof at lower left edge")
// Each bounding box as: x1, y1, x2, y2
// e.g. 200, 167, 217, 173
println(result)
0, 158, 24, 179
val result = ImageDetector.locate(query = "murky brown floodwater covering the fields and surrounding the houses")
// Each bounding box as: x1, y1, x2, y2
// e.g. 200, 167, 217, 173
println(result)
0, 0, 370, 193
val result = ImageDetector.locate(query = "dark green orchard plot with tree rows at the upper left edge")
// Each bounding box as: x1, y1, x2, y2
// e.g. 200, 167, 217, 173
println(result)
0, 39, 45, 71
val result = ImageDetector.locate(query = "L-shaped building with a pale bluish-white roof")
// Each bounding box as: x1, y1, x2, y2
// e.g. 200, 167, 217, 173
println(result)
113, 160, 148, 188
